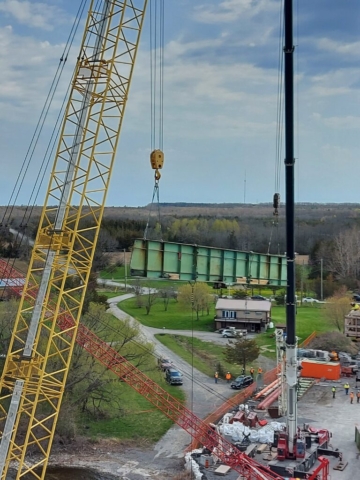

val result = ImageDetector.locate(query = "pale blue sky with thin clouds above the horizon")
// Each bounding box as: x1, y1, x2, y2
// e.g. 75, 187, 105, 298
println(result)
0, 0, 360, 206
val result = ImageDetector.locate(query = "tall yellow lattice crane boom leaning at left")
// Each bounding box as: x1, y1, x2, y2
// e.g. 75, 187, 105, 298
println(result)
0, 0, 147, 480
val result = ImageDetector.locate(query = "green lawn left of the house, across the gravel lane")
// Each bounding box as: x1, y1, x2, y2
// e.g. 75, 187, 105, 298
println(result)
119, 295, 215, 332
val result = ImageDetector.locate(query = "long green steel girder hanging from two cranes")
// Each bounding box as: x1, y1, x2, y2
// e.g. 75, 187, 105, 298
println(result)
130, 239, 287, 287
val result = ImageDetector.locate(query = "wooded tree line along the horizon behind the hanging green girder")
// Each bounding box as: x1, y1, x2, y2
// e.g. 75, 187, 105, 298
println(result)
0, 204, 360, 296
